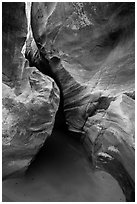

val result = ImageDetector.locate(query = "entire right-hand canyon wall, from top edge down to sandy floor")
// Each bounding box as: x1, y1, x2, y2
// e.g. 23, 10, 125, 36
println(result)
28, 2, 135, 201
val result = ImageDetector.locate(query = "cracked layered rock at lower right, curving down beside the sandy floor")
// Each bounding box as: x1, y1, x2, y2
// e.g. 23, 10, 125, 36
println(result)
83, 94, 135, 200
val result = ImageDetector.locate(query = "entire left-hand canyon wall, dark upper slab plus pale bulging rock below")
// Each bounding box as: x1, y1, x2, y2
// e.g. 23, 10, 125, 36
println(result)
2, 3, 60, 178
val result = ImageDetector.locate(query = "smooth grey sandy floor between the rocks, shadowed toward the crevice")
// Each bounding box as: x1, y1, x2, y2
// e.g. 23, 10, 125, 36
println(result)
2, 131, 125, 202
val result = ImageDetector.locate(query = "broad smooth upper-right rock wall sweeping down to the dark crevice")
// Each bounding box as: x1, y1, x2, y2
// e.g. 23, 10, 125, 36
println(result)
32, 3, 134, 129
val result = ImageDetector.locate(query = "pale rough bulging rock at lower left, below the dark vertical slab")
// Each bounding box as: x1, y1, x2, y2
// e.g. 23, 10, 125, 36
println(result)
2, 68, 59, 178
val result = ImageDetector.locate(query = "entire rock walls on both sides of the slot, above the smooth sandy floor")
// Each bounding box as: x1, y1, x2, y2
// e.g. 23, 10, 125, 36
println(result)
3, 2, 135, 201
